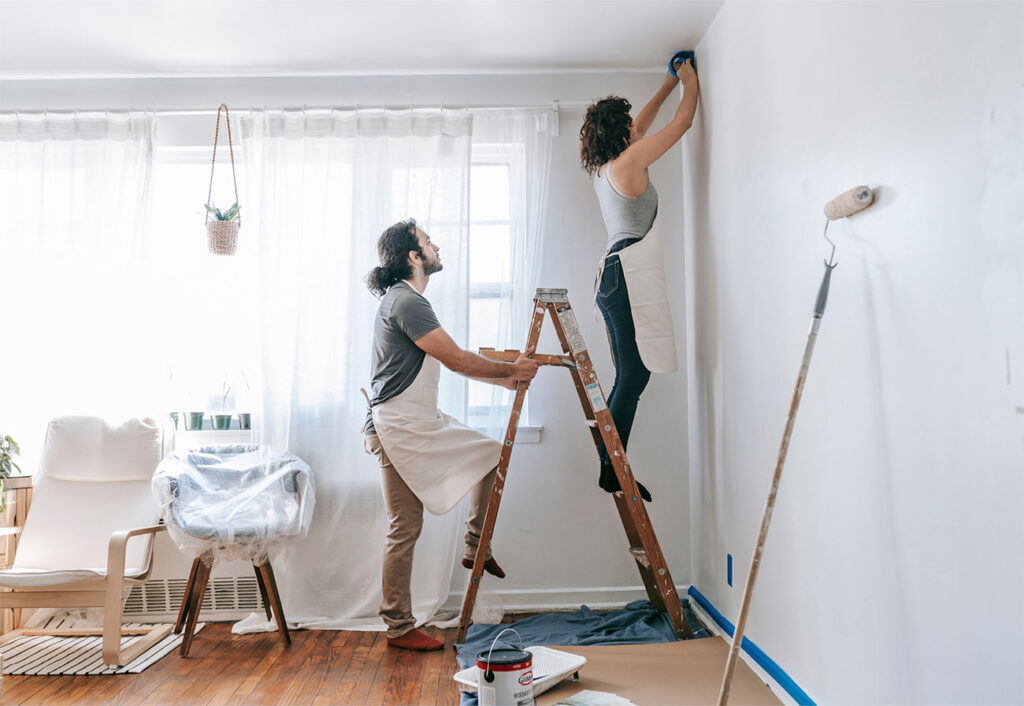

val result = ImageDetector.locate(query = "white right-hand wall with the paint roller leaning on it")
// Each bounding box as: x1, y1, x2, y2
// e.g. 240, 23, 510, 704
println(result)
684, 2, 1024, 703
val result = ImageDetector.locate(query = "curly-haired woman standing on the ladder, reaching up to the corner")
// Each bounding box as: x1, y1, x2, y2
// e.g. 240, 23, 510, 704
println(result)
580, 59, 697, 501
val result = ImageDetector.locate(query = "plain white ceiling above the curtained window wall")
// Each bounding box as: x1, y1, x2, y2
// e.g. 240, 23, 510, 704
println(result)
0, 0, 722, 79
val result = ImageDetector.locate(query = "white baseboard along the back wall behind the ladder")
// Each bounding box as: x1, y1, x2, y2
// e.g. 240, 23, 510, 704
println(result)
441, 584, 689, 613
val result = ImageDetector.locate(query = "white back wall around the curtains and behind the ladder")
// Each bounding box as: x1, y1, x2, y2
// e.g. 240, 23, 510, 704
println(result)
0, 72, 690, 607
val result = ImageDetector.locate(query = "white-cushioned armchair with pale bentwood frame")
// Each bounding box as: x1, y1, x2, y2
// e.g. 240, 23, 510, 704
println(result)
0, 417, 171, 666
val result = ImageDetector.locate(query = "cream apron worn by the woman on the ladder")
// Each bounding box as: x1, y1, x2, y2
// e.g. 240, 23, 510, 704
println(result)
597, 224, 678, 373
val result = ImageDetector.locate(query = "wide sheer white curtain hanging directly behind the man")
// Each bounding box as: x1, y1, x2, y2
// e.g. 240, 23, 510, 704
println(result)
241, 106, 472, 629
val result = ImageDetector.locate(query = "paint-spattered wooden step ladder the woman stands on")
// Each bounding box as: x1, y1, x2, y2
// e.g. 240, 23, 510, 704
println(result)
456, 289, 693, 642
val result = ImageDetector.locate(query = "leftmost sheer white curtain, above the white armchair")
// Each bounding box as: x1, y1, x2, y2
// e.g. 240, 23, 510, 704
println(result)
0, 113, 155, 472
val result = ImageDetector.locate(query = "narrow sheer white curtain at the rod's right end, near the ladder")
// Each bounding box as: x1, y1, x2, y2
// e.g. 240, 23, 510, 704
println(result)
473, 109, 558, 437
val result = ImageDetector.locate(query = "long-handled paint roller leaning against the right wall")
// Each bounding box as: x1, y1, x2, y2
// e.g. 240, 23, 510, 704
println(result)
718, 186, 874, 706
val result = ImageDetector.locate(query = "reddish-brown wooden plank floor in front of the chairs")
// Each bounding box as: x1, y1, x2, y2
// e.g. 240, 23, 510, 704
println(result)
0, 623, 459, 704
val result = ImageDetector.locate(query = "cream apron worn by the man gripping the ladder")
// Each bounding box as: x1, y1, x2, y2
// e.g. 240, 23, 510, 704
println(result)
373, 356, 502, 514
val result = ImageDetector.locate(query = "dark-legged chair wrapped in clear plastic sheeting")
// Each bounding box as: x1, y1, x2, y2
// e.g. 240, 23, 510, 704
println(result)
153, 445, 314, 657
